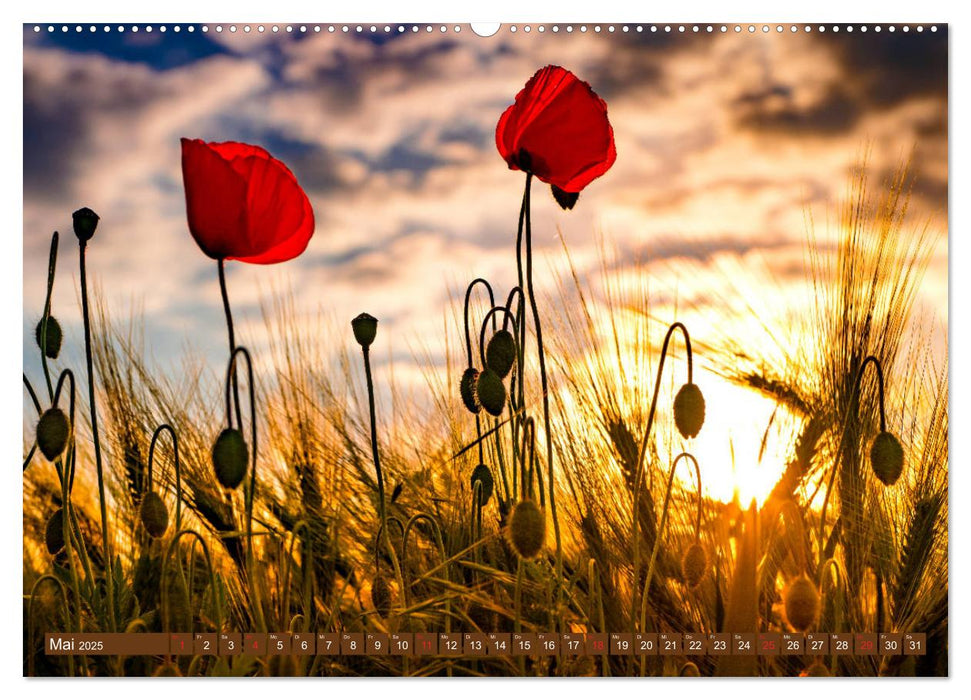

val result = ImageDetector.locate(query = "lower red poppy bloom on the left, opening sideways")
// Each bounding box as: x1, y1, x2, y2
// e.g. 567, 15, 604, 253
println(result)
182, 139, 314, 265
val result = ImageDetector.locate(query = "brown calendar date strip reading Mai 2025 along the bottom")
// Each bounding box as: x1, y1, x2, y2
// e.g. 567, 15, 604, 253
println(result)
44, 632, 927, 657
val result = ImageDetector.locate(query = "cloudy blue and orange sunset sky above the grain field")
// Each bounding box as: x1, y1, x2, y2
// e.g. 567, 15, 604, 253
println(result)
23, 25, 948, 500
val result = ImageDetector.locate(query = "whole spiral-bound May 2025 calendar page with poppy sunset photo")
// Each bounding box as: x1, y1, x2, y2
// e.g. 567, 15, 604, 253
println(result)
21, 20, 950, 680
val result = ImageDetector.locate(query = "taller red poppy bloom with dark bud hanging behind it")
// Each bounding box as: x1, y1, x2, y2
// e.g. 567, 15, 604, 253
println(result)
496, 66, 617, 193
